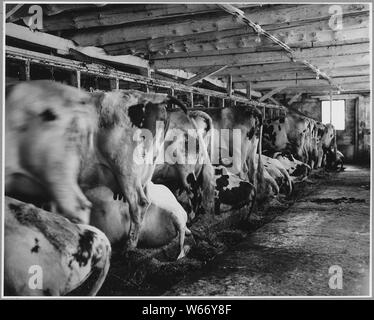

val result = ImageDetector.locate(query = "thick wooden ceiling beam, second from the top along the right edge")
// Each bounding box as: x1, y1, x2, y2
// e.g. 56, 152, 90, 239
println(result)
104, 12, 370, 54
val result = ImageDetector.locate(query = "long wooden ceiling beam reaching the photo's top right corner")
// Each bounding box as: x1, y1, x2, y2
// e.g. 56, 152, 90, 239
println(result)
71, 4, 369, 46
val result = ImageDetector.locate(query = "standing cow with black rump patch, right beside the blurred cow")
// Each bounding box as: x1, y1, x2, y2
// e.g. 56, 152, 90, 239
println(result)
79, 90, 187, 249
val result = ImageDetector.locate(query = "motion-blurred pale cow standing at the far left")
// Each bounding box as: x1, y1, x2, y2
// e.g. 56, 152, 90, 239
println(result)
5, 81, 97, 223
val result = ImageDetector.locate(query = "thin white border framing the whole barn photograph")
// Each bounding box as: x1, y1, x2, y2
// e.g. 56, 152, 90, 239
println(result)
0, 0, 374, 301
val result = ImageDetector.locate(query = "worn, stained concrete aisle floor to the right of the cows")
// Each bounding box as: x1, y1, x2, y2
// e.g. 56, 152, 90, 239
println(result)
164, 167, 370, 296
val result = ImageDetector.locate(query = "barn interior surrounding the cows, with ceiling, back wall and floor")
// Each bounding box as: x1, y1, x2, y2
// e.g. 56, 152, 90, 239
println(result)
5, 2, 371, 296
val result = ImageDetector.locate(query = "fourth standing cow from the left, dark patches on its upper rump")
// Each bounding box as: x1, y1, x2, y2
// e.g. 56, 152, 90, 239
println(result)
206, 106, 279, 201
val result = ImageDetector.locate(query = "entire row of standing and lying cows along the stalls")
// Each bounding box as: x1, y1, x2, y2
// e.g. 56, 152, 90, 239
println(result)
4, 80, 337, 295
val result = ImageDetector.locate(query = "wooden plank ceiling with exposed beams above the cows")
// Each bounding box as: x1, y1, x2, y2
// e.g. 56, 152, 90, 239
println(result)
7, 3, 371, 94
